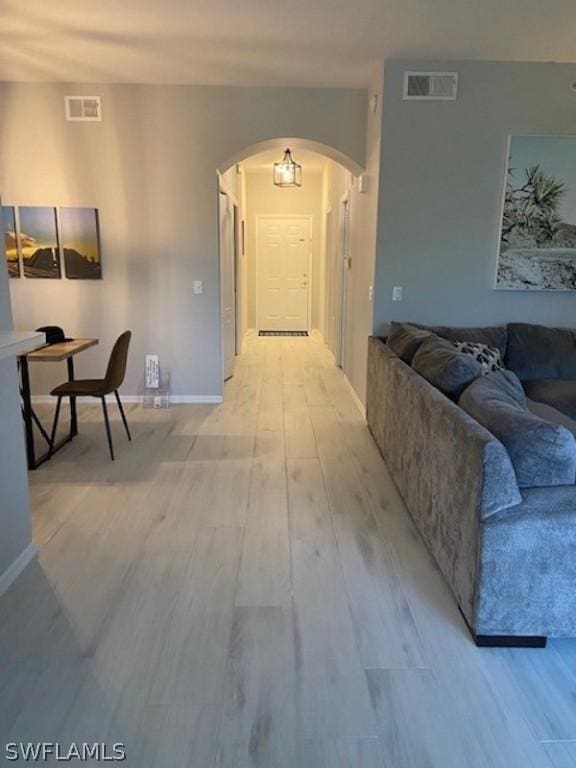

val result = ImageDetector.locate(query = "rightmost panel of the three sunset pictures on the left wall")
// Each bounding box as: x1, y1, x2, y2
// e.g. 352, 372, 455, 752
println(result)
59, 208, 102, 280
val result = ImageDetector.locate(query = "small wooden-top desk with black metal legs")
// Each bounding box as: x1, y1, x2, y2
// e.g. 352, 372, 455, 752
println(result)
18, 339, 98, 469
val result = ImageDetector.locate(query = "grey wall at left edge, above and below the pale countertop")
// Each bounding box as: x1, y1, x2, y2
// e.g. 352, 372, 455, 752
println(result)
0, 238, 32, 577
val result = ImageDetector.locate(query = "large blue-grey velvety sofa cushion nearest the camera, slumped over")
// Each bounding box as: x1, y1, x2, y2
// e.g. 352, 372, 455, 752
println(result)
458, 371, 576, 488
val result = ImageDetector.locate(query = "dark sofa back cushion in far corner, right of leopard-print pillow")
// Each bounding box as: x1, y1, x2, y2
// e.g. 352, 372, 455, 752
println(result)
505, 323, 576, 381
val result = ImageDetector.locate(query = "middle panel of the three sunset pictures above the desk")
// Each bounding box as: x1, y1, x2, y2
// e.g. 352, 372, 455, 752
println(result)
18, 206, 60, 279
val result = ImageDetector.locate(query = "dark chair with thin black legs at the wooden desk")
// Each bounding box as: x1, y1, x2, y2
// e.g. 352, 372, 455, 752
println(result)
50, 331, 132, 461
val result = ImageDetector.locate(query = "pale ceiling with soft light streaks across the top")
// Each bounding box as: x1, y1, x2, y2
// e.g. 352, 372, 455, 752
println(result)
0, 0, 576, 86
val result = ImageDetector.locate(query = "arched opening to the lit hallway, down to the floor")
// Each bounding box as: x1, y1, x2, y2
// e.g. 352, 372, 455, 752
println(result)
219, 139, 356, 379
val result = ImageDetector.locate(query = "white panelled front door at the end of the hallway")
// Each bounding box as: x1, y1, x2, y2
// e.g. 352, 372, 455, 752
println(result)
257, 216, 312, 331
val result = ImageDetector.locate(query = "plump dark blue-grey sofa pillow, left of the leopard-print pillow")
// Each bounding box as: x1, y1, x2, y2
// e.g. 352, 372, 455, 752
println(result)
412, 336, 482, 400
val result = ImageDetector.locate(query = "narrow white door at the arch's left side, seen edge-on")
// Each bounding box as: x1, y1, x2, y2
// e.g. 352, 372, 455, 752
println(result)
219, 192, 236, 380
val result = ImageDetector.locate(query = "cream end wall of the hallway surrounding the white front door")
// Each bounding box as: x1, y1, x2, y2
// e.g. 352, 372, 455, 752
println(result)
245, 168, 324, 328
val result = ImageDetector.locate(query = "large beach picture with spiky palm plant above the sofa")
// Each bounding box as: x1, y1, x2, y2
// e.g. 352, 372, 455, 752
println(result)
496, 136, 576, 291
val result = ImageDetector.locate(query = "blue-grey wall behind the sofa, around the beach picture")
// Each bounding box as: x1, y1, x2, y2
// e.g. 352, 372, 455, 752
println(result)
374, 61, 576, 332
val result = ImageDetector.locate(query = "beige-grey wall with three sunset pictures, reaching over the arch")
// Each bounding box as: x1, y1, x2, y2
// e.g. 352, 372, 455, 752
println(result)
0, 83, 366, 396
